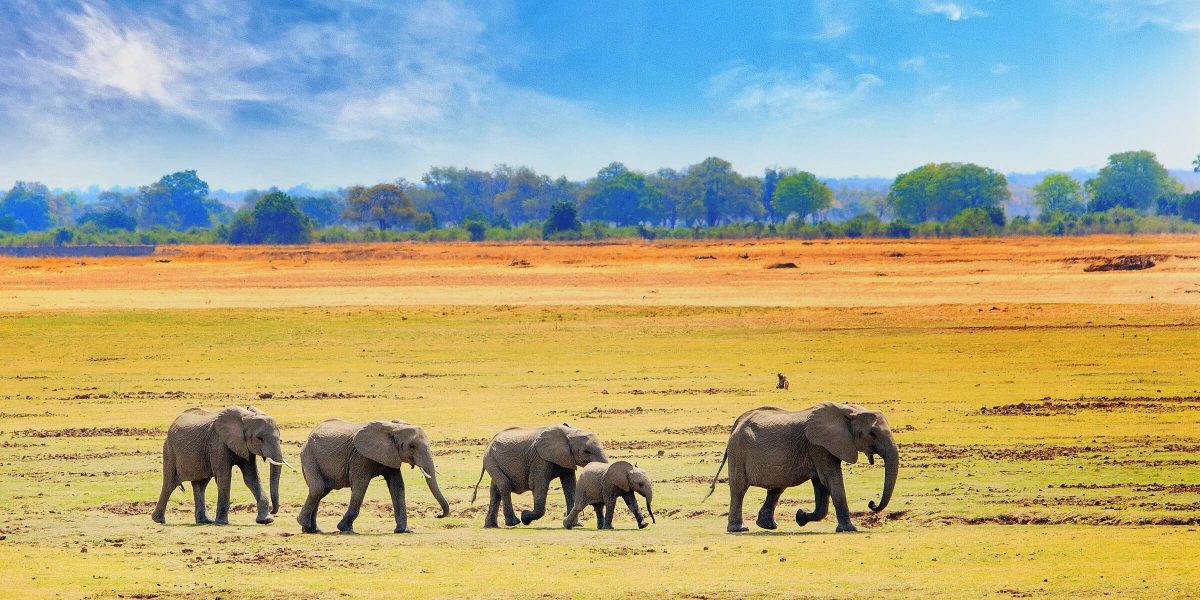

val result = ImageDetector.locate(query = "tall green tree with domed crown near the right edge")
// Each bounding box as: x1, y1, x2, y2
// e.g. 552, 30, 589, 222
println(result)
1085, 150, 1182, 212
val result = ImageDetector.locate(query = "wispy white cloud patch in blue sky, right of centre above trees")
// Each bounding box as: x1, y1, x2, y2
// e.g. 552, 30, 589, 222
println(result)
706, 65, 883, 122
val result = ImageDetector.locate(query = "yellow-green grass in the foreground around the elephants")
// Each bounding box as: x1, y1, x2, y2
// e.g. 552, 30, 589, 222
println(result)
0, 305, 1200, 598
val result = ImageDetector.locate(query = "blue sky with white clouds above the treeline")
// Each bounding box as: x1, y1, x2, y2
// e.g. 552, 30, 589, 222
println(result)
0, 0, 1200, 188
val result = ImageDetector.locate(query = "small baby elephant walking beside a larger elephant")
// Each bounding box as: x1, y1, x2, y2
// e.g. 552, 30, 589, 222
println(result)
563, 461, 654, 529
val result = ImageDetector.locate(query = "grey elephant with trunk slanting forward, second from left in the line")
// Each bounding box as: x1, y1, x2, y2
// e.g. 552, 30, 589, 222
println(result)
296, 419, 450, 533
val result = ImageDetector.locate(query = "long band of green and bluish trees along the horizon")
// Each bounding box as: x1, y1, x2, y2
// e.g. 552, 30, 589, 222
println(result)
0, 151, 1200, 244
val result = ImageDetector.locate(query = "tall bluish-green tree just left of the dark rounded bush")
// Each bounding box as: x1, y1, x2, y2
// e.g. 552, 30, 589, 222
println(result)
138, 170, 221, 230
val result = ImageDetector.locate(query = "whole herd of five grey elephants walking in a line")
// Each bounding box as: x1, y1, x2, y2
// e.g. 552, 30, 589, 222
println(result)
152, 402, 899, 533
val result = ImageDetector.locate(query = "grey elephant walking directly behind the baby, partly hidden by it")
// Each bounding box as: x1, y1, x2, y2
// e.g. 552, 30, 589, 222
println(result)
470, 422, 608, 528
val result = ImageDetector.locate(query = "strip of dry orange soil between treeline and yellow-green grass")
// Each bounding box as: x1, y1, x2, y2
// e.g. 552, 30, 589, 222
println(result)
0, 235, 1200, 312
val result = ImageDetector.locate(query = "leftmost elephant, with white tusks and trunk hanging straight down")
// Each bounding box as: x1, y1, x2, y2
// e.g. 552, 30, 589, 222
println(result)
152, 407, 287, 524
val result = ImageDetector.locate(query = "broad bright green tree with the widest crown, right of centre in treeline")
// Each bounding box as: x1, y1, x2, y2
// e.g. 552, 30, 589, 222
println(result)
888, 163, 1010, 223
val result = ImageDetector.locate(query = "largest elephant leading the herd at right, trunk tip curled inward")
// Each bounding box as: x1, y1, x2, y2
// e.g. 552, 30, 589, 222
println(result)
704, 402, 900, 532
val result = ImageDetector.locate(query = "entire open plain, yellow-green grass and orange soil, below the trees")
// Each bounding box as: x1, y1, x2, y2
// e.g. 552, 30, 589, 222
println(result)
0, 238, 1200, 598
